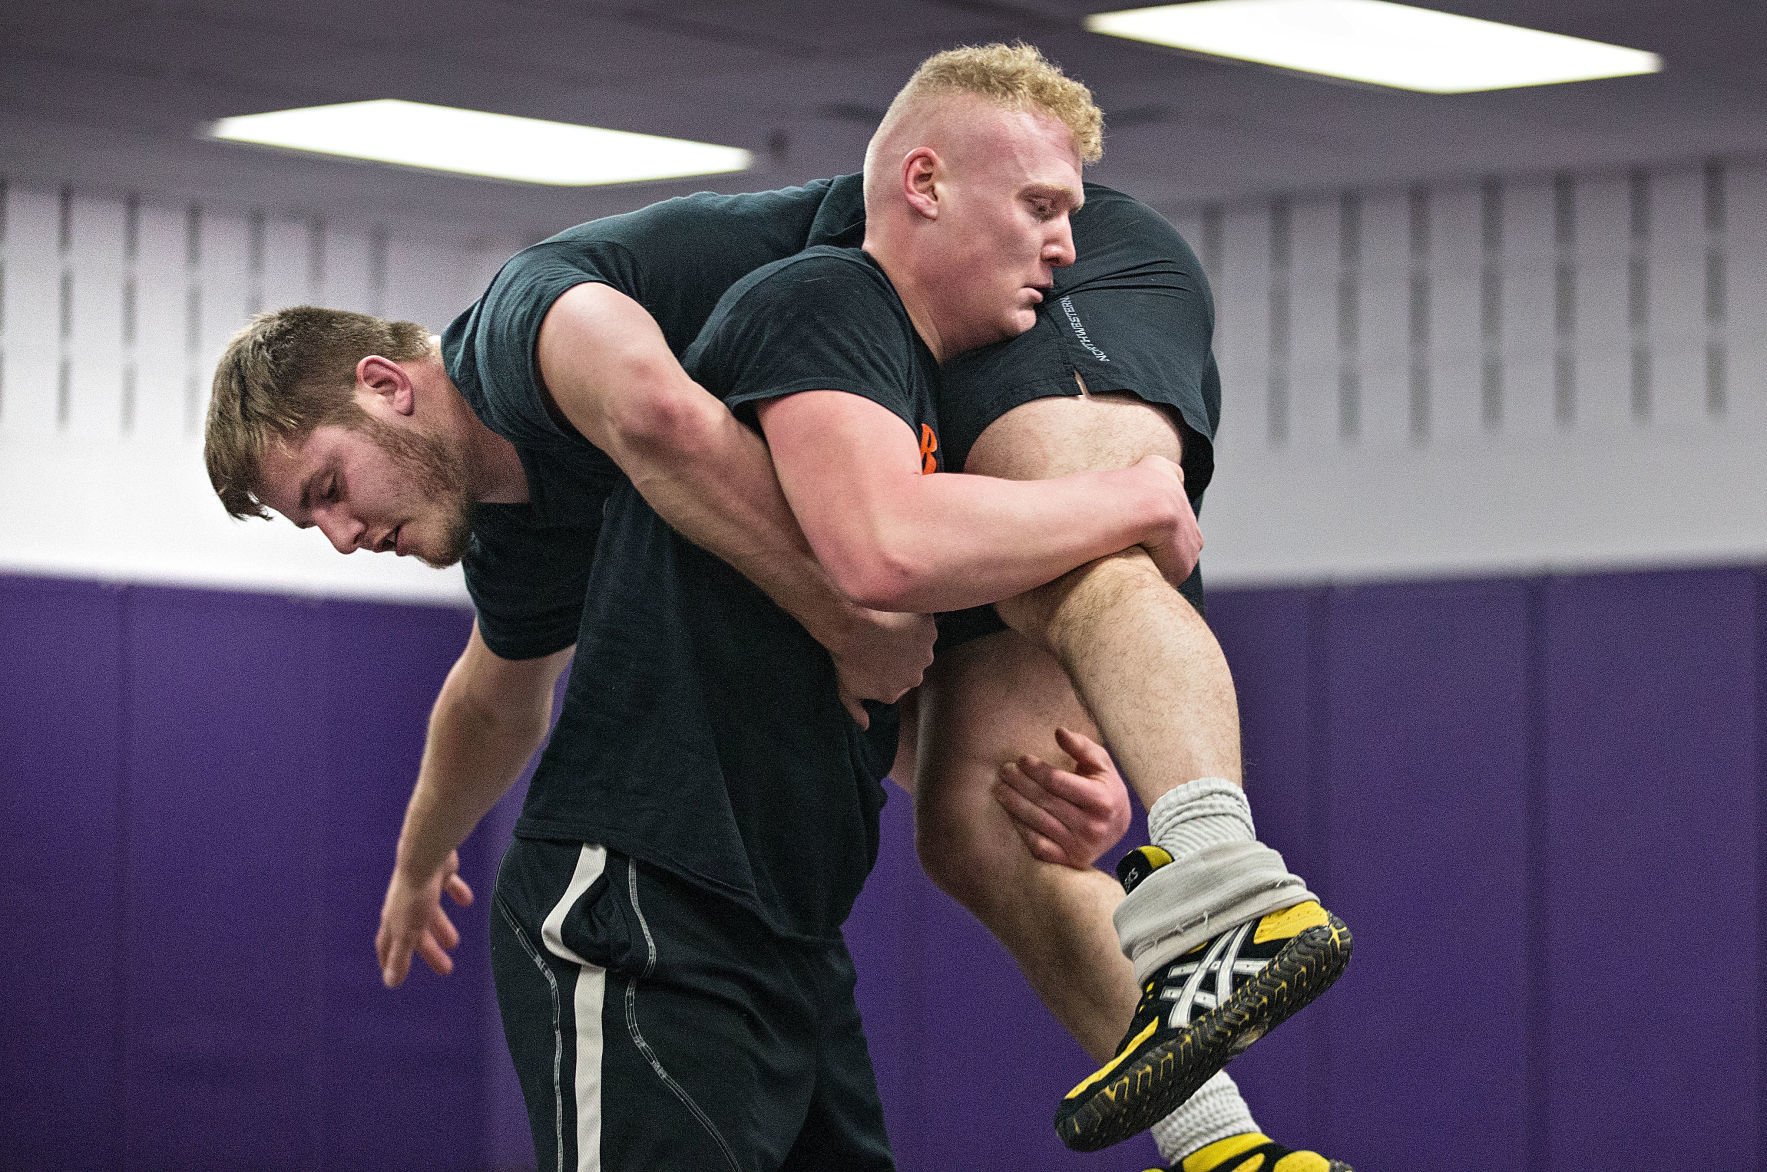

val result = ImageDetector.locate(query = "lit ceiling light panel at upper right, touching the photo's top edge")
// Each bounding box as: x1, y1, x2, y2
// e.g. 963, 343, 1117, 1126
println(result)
1087, 0, 1663, 94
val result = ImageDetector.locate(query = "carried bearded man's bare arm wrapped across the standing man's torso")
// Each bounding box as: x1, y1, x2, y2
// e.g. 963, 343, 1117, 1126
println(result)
539, 285, 933, 723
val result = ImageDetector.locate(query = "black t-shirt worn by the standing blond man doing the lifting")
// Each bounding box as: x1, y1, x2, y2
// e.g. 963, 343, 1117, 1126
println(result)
516, 247, 938, 939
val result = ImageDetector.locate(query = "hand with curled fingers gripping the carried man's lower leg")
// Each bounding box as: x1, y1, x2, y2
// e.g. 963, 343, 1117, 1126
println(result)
993, 728, 1131, 868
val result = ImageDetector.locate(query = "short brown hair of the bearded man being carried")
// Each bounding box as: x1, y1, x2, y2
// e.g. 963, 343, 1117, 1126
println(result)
203, 306, 429, 518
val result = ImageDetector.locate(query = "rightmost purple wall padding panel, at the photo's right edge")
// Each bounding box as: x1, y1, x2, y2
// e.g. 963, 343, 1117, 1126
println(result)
1539, 571, 1763, 1167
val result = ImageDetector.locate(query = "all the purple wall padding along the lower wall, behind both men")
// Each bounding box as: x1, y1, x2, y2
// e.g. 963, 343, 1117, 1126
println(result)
0, 569, 1767, 1172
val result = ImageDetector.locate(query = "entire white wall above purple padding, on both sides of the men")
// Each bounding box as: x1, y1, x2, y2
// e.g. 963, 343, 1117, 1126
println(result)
0, 161, 1767, 601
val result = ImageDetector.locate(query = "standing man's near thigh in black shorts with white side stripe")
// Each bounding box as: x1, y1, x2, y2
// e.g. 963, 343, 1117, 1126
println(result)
493, 841, 815, 1172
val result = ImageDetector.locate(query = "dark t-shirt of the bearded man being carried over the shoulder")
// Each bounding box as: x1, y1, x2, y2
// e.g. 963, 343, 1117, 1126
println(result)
442, 175, 864, 659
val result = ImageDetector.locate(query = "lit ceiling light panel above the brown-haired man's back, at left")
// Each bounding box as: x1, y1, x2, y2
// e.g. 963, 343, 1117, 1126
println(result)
209, 97, 751, 187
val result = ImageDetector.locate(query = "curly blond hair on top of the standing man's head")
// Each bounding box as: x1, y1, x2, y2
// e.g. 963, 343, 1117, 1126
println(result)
873, 41, 1104, 163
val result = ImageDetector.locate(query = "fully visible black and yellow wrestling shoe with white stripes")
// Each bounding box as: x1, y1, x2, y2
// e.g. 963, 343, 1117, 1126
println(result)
1055, 847, 1350, 1151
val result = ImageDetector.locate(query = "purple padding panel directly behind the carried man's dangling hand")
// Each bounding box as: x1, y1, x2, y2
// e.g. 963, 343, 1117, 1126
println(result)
313, 603, 500, 1168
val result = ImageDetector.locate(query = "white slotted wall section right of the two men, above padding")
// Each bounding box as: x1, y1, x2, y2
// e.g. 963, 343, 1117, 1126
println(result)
1173, 161, 1767, 583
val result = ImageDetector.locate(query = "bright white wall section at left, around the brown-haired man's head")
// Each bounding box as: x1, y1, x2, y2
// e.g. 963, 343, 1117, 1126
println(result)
0, 184, 519, 601
